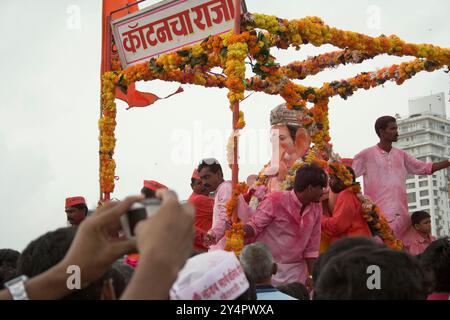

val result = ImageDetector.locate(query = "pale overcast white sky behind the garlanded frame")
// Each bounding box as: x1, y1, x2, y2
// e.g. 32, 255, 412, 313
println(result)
0, 0, 450, 250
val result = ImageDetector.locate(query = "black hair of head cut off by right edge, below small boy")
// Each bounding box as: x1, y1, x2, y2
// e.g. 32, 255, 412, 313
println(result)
420, 237, 450, 292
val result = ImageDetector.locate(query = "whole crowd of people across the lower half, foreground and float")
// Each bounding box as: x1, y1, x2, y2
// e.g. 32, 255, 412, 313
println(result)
0, 114, 450, 300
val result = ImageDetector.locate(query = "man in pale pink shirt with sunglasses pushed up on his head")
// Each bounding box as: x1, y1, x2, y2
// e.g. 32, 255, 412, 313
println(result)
201, 158, 250, 250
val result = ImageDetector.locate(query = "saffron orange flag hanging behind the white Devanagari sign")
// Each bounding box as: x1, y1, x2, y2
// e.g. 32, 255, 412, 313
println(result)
100, 0, 183, 109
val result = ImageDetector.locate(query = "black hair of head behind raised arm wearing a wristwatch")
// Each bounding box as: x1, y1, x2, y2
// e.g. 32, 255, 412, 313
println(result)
17, 227, 111, 300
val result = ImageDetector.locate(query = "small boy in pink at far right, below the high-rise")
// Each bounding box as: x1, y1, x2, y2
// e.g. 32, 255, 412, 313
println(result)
403, 211, 436, 255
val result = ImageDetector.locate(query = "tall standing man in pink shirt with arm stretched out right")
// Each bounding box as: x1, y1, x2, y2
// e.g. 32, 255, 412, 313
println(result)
352, 116, 450, 239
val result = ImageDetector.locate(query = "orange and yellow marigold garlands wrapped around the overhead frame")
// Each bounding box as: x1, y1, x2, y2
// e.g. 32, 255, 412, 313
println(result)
99, 13, 450, 252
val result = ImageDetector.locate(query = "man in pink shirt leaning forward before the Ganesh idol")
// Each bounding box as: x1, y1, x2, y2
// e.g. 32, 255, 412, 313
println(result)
244, 165, 327, 290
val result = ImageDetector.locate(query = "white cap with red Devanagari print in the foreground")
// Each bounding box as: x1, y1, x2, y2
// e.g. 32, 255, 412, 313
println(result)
170, 250, 249, 300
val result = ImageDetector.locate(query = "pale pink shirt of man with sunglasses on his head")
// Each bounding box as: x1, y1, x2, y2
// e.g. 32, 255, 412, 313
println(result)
208, 181, 251, 250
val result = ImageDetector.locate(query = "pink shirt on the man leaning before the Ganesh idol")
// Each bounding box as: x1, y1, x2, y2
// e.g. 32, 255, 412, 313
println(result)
248, 190, 322, 285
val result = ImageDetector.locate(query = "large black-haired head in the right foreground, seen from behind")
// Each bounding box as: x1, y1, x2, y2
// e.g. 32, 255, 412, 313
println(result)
314, 246, 428, 300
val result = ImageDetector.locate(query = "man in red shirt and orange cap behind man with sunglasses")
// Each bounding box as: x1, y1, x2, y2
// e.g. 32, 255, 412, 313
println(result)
188, 169, 214, 251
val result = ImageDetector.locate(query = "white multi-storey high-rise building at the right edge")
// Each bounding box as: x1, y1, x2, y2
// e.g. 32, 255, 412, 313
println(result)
394, 93, 450, 237
